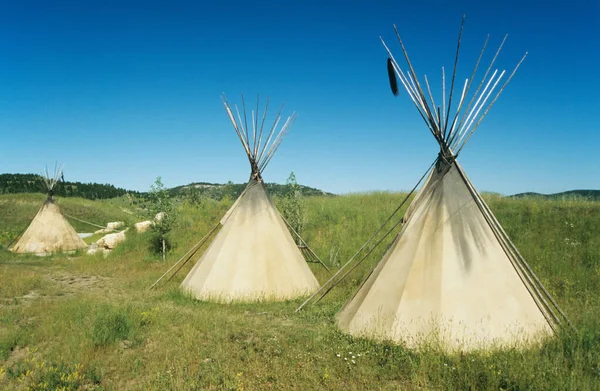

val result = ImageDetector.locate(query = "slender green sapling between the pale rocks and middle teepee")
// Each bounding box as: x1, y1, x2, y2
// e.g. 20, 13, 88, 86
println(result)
148, 177, 176, 261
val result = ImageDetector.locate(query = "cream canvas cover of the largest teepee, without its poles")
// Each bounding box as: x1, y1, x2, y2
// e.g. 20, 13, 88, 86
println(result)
337, 161, 552, 350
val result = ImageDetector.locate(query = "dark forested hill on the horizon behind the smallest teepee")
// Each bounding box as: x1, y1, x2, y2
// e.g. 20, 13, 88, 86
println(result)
0, 174, 137, 200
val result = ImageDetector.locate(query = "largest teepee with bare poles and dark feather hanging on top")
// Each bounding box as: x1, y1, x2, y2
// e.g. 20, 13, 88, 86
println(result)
298, 19, 564, 350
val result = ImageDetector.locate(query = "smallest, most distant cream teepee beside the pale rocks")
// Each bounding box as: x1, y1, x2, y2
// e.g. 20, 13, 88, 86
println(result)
10, 167, 87, 255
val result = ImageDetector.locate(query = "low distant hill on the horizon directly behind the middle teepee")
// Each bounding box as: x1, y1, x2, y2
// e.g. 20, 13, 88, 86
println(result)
169, 182, 334, 200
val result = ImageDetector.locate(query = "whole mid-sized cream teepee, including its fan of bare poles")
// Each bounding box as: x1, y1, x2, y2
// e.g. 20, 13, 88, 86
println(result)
181, 96, 319, 302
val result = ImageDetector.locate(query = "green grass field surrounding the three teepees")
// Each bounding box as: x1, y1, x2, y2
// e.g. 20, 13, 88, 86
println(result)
0, 193, 600, 390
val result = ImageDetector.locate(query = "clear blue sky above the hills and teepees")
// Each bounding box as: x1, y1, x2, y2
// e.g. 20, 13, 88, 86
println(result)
0, 0, 600, 194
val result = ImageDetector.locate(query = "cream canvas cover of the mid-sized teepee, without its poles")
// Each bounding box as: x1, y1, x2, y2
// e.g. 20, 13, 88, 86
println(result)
181, 181, 319, 302
